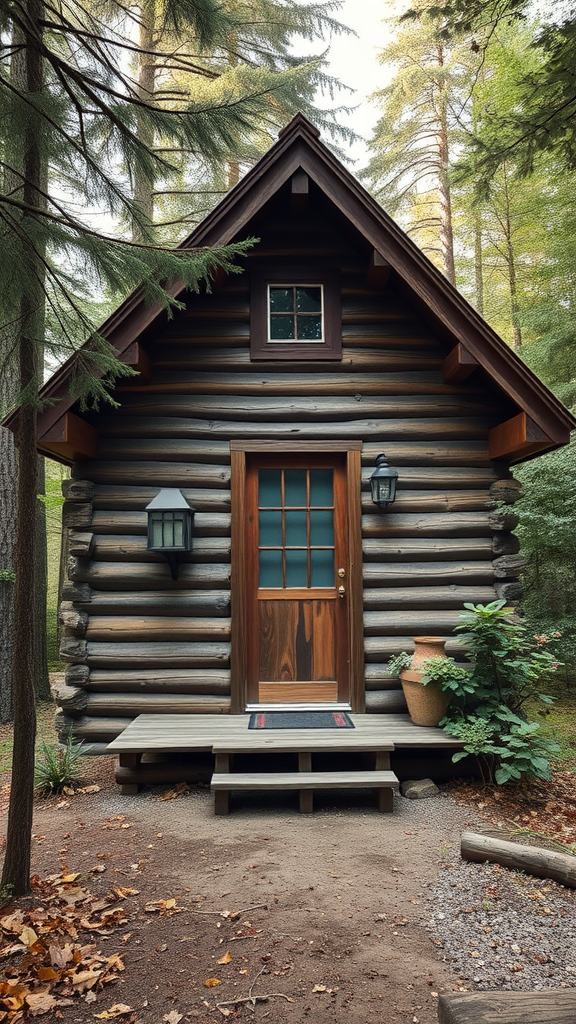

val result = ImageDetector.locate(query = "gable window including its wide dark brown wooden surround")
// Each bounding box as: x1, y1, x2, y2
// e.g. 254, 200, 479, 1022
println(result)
250, 266, 342, 360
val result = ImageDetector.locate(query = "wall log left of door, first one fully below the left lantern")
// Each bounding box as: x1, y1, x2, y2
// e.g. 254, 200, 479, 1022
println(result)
63, 584, 230, 615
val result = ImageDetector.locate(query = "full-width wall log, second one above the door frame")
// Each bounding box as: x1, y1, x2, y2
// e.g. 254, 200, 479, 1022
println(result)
107, 389, 497, 421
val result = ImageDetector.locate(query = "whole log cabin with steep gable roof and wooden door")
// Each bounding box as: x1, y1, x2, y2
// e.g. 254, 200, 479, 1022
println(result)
8, 115, 576, 792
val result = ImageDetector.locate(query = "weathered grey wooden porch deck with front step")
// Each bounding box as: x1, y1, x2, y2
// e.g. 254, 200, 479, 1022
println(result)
108, 715, 461, 814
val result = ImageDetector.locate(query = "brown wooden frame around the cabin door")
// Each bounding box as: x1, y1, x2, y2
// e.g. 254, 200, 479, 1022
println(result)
230, 440, 366, 715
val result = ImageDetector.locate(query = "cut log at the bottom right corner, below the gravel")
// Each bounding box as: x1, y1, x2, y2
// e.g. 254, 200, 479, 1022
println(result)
438, 988, 576, 1024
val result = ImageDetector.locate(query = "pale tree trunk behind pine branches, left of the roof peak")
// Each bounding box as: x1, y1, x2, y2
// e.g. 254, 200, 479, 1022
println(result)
132, 0, 156, 242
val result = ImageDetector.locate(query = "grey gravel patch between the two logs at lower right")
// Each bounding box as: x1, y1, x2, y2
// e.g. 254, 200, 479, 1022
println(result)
427, 861, 576, 991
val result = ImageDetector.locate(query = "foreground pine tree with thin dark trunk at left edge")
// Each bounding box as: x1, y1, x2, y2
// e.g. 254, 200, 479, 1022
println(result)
0, 0, 268, 896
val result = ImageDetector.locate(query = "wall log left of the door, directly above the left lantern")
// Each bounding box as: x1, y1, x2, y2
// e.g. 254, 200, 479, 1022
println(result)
73, 459, 230, 494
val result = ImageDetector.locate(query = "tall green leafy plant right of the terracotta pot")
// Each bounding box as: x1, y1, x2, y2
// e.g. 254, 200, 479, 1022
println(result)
441, 601, 560, 785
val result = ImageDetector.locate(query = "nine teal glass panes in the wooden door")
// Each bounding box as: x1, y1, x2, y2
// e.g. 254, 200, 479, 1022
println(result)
258, 468, 334, 589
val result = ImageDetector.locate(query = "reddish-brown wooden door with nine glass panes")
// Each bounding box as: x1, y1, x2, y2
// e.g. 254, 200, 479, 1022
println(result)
246, 453, 349, 705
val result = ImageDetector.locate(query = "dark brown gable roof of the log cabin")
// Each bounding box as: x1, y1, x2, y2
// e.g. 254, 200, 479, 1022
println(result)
4, 114, 576, 462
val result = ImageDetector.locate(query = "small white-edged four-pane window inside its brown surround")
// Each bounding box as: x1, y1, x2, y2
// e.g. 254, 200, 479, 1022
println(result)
269, 285, 324, 342
